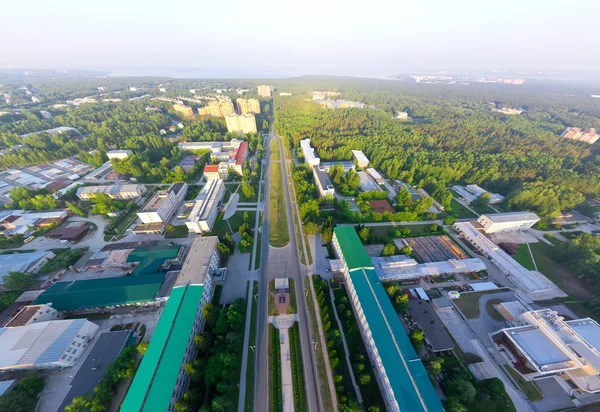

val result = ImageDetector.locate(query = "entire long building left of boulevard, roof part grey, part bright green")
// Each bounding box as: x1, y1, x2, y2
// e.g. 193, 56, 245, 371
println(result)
121, 236, 219, 412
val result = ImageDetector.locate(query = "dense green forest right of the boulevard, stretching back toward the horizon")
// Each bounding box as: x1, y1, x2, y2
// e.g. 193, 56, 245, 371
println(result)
274, 81, 600, 217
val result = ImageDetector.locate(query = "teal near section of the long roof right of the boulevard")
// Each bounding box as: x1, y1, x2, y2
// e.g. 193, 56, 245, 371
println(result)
350, 269, 444, 412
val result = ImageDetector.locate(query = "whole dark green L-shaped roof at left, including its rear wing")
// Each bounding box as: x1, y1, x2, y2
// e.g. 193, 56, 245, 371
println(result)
34, 246, 181, 311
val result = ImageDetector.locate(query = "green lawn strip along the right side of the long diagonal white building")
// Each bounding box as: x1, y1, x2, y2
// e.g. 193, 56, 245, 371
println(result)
529, 242, 592, 299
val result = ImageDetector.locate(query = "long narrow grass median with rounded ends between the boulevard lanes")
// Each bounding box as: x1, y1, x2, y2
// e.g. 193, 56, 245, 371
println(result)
269, 164, 290, 247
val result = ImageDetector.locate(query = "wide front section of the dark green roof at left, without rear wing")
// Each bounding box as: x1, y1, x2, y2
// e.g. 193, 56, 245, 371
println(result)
34, 273, 166, 311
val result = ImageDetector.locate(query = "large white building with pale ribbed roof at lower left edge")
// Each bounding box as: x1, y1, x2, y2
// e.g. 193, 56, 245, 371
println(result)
0, 319, 99, 371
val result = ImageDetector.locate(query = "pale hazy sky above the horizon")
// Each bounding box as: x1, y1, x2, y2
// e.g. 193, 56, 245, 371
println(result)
0, 0, 600, 77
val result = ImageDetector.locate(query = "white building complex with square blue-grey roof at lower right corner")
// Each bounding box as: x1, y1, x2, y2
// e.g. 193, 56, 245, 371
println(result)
491, 309, 600, 395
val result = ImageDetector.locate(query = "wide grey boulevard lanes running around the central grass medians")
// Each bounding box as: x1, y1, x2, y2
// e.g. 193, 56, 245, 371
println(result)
254, 135, 322, 412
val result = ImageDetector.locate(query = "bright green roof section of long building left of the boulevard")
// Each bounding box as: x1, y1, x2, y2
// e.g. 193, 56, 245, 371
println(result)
121, 285, 204, 412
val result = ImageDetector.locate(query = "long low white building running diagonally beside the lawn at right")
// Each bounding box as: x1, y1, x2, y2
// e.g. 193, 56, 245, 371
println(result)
454, 222, 566, 300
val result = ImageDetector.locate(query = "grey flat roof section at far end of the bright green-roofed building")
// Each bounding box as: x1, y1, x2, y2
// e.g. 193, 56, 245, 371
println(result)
175, 236, 219, 287
